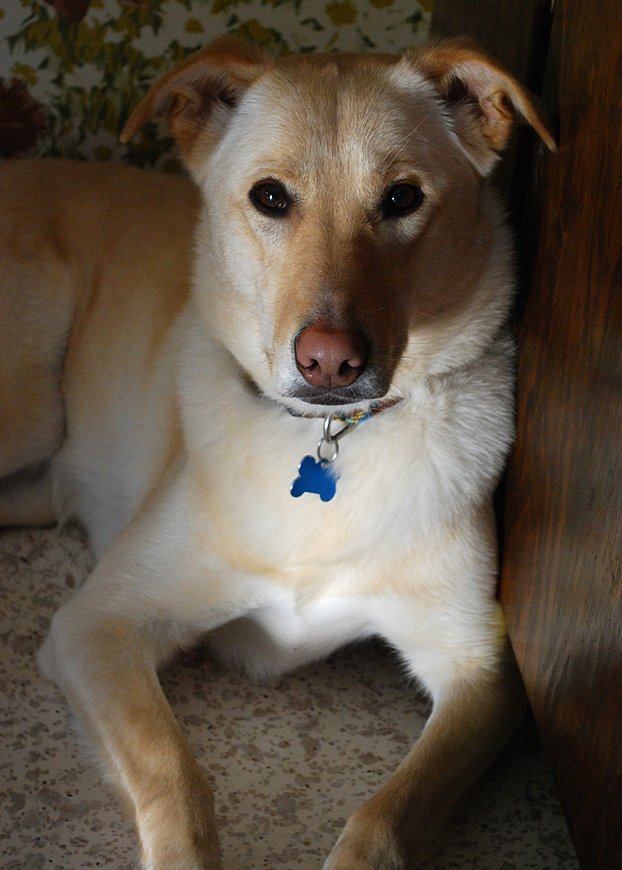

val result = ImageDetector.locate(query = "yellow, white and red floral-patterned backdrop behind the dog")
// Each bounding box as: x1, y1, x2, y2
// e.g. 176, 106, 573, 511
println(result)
0, 0, 432, 169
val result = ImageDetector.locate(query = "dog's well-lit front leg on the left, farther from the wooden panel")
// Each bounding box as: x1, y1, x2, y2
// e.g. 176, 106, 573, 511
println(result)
39, 544, 222, 870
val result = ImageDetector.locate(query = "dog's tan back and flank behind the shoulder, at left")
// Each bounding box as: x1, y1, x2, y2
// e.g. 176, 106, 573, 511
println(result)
0, 160, 198, 546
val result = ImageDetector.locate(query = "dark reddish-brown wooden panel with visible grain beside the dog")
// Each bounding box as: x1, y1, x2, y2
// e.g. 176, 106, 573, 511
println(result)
501, 0, 622, 870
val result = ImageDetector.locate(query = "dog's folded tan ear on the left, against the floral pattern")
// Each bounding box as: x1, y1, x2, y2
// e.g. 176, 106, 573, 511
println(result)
120, 36, 273, 164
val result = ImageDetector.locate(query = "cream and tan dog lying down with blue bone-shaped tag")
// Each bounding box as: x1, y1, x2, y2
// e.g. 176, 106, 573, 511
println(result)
0, 38, 555, 870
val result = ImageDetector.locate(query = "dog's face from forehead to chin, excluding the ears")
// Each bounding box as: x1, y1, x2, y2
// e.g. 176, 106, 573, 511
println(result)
197, 57, 488, 413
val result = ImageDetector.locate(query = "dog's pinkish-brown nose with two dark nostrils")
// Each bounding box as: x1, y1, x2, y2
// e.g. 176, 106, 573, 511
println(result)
296, 326, 368, 387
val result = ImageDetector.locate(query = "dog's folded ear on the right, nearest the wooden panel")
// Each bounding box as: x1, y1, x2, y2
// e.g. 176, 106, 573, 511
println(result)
402, 40, 556, 175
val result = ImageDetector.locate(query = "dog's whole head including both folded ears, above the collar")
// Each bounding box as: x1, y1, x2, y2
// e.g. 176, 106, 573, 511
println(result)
122, 38, 555, 414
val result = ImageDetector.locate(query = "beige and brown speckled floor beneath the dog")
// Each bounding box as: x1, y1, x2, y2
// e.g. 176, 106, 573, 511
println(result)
0, 531, 578, 870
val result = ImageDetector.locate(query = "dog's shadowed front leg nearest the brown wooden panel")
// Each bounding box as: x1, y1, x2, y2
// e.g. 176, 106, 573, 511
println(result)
324, 620, 525, 870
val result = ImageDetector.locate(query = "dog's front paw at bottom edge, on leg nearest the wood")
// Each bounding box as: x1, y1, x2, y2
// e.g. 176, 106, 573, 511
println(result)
324, 809, 406, 870
